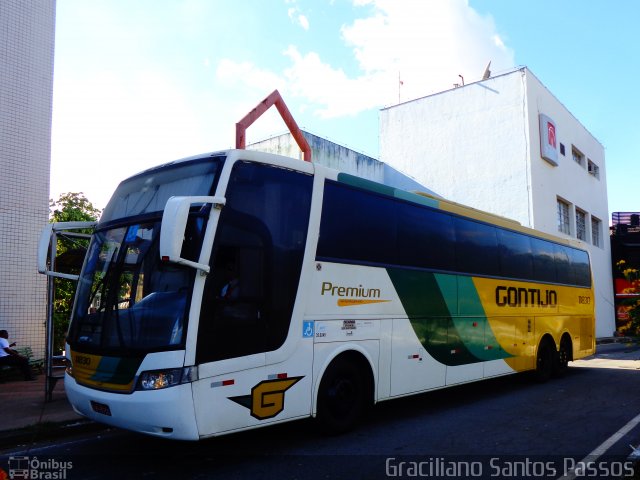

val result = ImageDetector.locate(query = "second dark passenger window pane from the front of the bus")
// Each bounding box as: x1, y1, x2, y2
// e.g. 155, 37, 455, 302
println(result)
398, 203, 456, 271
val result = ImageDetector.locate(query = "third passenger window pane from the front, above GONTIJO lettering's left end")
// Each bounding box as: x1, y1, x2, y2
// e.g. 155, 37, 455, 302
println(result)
454, 218, 500, 276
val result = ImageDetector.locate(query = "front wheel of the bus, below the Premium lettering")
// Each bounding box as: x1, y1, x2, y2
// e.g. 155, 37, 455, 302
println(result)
317, 360, 365, 435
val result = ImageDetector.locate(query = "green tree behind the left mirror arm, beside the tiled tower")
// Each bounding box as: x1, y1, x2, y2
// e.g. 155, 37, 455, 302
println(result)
49, 192, 101, 352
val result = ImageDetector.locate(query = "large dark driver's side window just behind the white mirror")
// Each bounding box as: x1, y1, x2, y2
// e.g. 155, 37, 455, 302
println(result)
196, 162, 313, 363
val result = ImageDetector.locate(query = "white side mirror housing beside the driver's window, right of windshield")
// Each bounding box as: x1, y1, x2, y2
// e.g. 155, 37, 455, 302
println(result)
160, 197, 226, 273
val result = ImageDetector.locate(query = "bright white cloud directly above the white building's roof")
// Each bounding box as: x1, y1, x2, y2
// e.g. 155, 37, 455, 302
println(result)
342, 0, 513, 103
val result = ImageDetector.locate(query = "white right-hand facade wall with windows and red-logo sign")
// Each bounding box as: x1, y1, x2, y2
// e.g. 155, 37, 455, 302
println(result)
526, 70, 615, 337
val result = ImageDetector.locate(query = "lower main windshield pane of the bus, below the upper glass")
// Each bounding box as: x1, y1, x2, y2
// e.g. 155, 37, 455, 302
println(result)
68, 220, 198, 353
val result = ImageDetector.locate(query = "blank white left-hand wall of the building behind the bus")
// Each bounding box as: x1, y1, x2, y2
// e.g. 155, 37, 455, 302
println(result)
380, 70, 530, 225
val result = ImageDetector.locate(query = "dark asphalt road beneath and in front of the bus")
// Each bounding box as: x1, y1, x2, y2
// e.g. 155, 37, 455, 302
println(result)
0, 345, 640, 480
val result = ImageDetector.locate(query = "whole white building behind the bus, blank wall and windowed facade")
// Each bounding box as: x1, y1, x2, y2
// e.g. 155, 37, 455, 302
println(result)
380, 68, 615, 337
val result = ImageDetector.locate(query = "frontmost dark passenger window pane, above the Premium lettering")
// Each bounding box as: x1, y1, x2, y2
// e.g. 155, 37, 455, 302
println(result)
318, 182, 397, 264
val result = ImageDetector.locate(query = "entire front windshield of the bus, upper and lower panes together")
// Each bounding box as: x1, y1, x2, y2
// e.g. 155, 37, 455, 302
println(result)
68, 158, 223, 354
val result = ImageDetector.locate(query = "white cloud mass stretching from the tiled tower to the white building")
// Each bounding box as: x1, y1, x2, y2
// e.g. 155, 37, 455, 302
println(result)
51, 0, 513, 207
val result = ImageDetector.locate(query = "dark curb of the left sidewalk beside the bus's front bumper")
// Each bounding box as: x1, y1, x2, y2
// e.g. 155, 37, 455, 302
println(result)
0, 420, 110, 450
